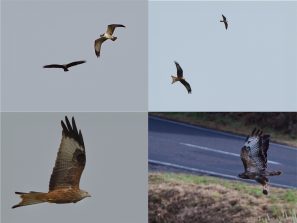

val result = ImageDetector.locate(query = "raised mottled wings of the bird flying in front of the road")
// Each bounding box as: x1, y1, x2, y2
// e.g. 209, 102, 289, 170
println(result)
240, 129, 269, 173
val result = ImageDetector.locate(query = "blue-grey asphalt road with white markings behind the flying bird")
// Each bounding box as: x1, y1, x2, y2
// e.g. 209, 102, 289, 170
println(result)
148, 116, 297, 188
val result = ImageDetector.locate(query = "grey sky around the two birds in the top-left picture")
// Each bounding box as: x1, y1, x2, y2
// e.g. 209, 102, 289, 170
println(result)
1, 1, 148, 111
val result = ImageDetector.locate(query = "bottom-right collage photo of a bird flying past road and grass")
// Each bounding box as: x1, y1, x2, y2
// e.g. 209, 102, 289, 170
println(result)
148, 112, 297, 223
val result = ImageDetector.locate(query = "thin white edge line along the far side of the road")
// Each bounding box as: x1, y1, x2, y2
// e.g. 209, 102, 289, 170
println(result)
149, 115, 297, 151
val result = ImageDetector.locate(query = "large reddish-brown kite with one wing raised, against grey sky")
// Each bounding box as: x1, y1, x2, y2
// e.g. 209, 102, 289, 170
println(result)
12, 117, 90, 208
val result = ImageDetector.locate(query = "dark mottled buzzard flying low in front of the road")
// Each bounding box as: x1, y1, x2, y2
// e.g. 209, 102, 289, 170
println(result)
238, 128, 281, 195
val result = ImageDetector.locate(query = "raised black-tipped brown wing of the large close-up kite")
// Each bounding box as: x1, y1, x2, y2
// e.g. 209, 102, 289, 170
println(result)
49, 117, 86, 191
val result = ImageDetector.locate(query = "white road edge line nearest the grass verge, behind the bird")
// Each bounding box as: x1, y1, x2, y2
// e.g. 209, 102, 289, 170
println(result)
148, 159, 296, 189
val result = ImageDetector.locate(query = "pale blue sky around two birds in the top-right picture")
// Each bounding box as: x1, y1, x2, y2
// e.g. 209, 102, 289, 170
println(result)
149, 1, 297, 111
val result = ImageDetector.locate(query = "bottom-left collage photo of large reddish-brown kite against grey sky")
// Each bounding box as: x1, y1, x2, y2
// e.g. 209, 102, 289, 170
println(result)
1, 112, 148, 223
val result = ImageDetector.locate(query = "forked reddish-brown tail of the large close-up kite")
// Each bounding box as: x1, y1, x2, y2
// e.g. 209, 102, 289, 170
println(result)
12, 191, 47, 208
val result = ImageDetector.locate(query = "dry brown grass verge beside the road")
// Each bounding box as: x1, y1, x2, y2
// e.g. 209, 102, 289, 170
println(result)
149, 173, 297, 223
